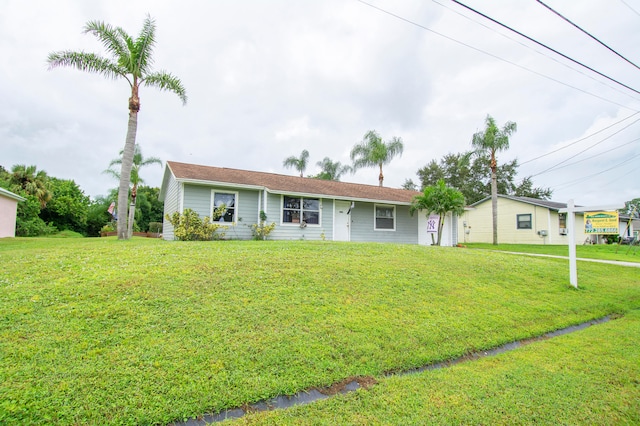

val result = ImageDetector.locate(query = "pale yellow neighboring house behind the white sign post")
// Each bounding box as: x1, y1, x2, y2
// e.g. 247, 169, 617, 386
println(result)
458, 195, 638, 244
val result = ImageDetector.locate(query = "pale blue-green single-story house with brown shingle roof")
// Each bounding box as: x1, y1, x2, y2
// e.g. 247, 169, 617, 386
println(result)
160, 161, 457, 245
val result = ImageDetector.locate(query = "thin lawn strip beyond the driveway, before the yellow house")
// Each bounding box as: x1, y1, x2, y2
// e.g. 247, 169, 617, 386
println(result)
466, 243, 640, 262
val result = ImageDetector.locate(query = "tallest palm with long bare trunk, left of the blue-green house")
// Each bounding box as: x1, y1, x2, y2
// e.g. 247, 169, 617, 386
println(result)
48, 15, 187, 239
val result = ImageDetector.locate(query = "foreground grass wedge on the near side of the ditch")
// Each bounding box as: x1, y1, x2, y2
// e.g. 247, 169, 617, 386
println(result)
234, 310, 640, 426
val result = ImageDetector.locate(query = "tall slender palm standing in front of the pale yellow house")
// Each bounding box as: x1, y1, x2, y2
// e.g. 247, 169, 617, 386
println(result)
471, 115, 518, 245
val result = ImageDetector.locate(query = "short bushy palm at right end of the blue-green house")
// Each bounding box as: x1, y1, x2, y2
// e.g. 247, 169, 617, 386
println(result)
409, 179, 465, 246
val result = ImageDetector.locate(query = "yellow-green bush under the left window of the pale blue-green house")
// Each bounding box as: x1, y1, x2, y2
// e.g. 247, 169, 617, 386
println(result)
165, 208, 228, 241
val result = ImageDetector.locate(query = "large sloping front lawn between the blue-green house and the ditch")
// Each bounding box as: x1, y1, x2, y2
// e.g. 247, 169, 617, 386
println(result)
0, 238, 640, 424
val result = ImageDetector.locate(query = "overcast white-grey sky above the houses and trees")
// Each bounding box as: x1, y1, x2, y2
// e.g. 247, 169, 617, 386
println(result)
0, 0, 640, 205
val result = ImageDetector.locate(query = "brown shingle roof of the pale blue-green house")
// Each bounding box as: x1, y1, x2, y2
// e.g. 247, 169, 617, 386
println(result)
167, 161, 420, 204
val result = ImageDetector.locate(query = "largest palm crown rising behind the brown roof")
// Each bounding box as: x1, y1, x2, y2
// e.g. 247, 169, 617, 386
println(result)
351, 130, 404, 186
